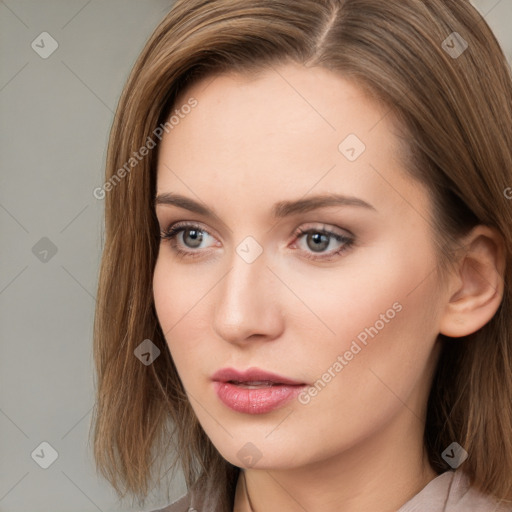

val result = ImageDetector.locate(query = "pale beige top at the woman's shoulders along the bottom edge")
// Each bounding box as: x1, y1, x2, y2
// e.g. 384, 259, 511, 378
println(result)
152, 469, 512, 512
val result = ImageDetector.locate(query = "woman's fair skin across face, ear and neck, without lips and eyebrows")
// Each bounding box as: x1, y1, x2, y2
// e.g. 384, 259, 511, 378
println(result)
153, 64, 503, 512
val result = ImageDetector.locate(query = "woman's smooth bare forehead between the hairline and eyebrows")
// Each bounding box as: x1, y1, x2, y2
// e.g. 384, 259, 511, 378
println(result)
157, 64, 428, 222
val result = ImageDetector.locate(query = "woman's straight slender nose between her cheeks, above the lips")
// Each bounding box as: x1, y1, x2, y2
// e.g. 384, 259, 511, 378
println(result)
214, 240, 279, 341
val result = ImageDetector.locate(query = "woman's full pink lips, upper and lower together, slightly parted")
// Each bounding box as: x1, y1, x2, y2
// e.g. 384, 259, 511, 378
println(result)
212, 368, 306, 414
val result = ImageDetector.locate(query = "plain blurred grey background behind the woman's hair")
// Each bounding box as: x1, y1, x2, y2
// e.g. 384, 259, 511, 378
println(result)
0, 0, 512, 512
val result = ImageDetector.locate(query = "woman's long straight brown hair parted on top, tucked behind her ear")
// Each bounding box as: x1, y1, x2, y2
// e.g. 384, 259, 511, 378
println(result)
91, 0, 512, 510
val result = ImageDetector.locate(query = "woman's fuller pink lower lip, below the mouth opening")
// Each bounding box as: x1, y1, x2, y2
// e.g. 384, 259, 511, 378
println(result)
214, 382, 306, 414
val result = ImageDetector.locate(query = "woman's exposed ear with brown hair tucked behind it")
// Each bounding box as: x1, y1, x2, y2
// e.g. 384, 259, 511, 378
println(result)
440, 225, 506, 338
